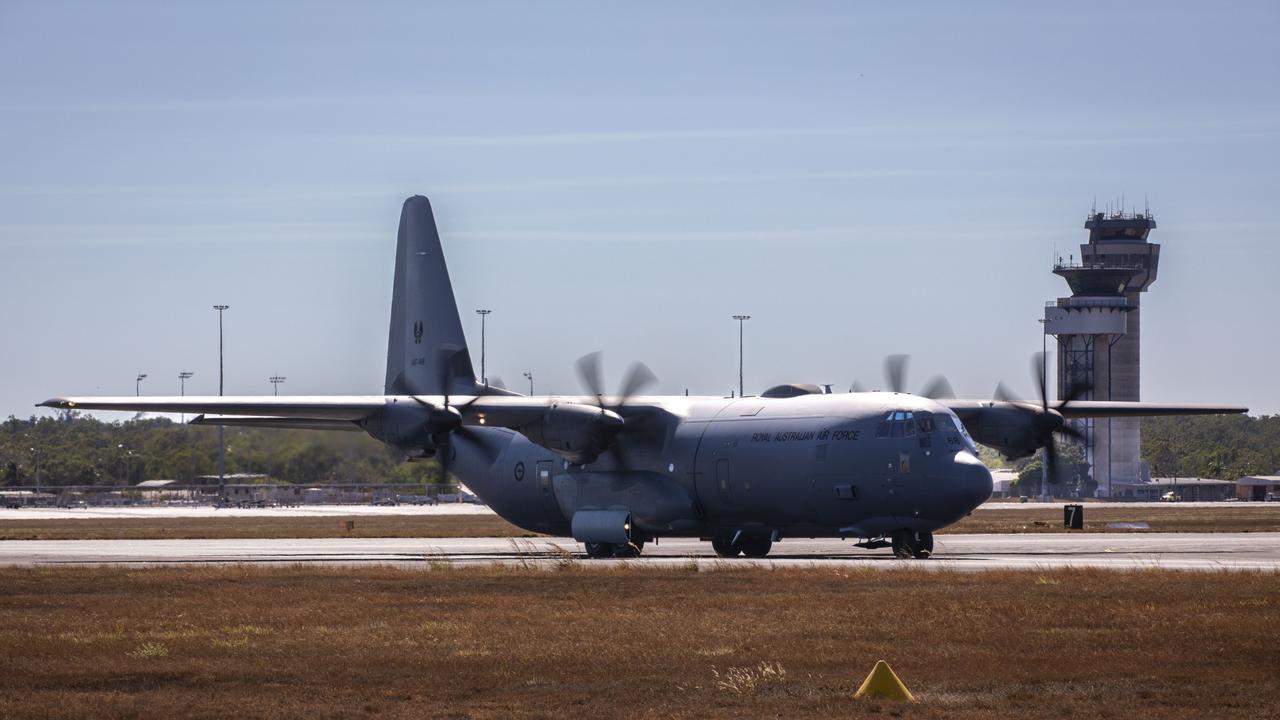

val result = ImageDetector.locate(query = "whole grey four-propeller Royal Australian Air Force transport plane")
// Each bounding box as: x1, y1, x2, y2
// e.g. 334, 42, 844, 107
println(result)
41, 196, 1245, 557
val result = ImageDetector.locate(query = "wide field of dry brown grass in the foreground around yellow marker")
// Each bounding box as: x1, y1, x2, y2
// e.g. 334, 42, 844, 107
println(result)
0, 562, 1280, 720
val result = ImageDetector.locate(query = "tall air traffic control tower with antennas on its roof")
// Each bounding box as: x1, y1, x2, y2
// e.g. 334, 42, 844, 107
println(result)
1044, 209, 1160, 489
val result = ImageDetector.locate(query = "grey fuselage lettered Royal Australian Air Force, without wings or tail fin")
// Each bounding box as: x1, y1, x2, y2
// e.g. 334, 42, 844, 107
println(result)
453, 392, 991, 538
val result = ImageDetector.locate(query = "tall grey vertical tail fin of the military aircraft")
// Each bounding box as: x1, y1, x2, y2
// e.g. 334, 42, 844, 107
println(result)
385, 195, 476, 395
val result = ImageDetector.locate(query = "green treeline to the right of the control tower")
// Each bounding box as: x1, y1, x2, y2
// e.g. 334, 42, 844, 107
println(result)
1142, 415, 1280, 480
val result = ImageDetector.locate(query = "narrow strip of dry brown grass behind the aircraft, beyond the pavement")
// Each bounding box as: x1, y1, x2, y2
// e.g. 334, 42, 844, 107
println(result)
0, 503, 1280, 541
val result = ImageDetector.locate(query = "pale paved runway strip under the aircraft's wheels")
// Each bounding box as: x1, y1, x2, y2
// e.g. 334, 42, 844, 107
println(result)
0, 533, 1280, 571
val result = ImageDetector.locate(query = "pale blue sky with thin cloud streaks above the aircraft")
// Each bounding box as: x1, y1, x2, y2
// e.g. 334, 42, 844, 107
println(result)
0, 1, 1280, 416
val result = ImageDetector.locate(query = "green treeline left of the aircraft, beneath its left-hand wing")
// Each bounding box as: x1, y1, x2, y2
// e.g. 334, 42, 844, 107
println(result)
0, 414, 439, 486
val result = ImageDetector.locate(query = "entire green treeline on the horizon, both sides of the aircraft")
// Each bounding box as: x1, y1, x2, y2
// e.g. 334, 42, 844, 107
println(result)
0, 414, 1280, 486
